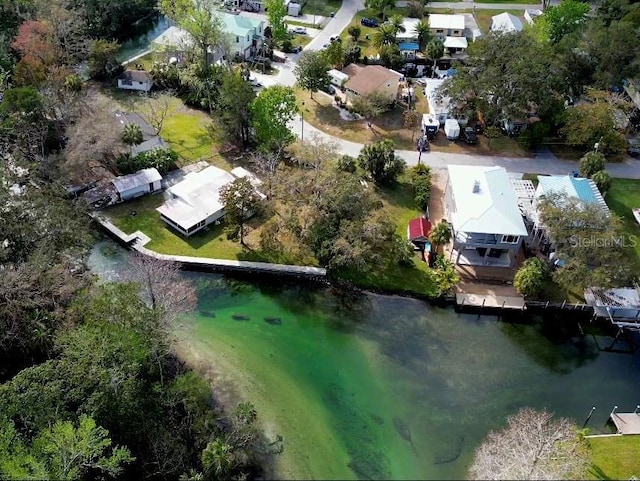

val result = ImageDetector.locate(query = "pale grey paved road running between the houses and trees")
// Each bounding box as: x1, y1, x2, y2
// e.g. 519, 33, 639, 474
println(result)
255, 0, 640, 179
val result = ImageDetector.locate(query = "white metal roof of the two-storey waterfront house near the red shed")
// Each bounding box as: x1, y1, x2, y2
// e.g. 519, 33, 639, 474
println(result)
447, 165, 528, 236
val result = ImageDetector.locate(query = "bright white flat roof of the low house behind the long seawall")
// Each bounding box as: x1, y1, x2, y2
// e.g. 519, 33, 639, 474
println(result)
156, 166, 235, 230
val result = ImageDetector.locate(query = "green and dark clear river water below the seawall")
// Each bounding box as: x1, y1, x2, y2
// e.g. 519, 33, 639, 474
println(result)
90, 242, 640, 479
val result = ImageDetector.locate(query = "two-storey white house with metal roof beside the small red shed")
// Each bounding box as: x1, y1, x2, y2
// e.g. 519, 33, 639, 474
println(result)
445, 165, 528, 267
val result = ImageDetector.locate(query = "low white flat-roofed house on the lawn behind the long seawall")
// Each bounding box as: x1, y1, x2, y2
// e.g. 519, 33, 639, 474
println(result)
156, 166, 265, 237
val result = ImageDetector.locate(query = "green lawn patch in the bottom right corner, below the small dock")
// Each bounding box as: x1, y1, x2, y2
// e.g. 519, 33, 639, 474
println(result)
589, 436, 640, 479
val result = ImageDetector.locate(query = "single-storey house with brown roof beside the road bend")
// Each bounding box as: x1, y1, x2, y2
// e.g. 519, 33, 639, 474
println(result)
342, 63, 403, 104
